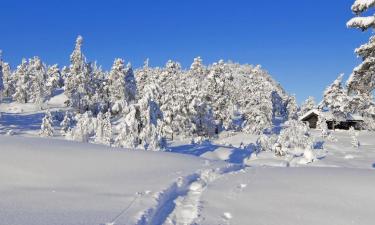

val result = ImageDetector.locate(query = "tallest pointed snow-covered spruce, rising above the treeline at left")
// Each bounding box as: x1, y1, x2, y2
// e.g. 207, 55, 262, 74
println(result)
64, 36, 95, 113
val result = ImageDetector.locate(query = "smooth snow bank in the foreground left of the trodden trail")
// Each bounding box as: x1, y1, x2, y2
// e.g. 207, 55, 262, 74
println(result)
0, 136, 224, 225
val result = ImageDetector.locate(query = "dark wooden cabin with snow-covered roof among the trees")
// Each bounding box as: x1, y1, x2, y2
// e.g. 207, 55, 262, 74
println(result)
299, 109, 363, 130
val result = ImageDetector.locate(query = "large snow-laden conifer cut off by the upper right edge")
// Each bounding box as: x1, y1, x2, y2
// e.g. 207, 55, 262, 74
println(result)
347, 0, 375, 95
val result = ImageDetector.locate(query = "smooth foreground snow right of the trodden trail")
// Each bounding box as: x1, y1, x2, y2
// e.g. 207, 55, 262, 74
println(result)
197, 167, 375, 225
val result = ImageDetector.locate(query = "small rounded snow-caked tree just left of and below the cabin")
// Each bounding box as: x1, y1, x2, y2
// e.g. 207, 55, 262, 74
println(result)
277, 120, 314, 155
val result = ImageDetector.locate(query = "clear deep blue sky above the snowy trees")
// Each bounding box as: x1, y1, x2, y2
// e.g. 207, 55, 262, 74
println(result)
0, 0, 369, 102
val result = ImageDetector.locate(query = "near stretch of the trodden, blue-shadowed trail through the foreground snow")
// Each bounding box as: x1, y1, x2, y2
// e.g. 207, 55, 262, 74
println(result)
136, 164, 244, 225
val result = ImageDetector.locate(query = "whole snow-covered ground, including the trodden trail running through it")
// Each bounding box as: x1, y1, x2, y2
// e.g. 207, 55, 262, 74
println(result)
0, 95, 375, 225
